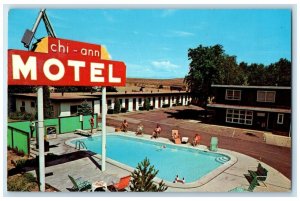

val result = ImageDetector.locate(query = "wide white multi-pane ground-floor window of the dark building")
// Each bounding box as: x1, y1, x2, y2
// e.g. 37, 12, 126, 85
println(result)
226, 109, 253, 125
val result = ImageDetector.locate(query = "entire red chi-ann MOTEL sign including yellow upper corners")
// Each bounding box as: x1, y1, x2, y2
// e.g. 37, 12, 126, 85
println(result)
8, 37, 126, 86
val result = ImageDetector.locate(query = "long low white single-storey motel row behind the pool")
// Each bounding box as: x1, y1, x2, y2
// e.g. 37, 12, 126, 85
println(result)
9, 91, 192, 117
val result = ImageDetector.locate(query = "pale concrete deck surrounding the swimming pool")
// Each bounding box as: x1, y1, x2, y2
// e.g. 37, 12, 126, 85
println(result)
32, 127, 291, 193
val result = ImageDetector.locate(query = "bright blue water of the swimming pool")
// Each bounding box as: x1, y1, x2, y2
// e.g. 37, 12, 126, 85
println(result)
71, 134, 230, 183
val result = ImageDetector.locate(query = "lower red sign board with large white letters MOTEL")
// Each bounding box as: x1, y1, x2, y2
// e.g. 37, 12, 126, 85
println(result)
8, 50, 126, 86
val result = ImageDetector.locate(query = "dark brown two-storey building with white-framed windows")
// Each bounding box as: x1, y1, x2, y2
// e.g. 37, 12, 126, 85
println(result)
207, 85, 291, 136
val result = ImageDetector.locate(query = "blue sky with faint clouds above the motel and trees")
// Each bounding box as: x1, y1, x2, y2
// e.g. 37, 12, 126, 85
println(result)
8, 8, 292, 79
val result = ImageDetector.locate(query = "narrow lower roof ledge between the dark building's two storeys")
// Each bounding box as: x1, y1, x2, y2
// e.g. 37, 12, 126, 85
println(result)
207, 103, 291, 113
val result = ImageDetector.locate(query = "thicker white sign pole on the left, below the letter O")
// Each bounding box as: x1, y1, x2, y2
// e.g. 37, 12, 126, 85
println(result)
37, 86, 45, 192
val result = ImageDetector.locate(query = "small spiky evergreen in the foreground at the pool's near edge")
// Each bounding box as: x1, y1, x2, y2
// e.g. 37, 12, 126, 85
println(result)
129, 158, 168, 192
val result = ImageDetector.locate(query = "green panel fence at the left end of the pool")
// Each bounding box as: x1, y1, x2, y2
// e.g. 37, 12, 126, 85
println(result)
7, 114, 98, 155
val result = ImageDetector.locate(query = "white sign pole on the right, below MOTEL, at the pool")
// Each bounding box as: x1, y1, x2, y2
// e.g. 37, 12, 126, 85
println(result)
101, 87, 107, 172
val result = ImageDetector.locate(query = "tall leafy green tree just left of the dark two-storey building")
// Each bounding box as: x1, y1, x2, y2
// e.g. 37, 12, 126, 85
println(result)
184, 45, 224, 106
